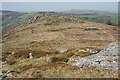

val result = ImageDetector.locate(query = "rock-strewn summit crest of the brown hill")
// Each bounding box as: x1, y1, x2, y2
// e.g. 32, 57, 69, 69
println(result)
26, 12, 83, 24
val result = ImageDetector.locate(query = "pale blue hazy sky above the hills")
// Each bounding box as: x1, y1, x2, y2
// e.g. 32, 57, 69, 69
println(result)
2, 2, 118, 12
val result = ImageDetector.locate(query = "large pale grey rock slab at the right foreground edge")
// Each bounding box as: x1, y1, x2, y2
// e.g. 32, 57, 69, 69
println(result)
70, 41, 120, 70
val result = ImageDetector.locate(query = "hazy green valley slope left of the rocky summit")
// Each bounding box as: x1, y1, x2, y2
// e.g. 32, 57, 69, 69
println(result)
1, 10, 37, 30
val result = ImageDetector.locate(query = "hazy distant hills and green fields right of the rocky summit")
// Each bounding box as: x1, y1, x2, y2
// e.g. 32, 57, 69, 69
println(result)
61, 9, 118, 26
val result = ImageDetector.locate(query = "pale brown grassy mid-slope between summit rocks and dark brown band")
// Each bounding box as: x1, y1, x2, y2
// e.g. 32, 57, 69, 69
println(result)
3, 21, 118, 52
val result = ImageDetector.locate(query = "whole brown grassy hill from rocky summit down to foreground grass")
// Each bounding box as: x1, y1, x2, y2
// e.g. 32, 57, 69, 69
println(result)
2, 12, 118, 78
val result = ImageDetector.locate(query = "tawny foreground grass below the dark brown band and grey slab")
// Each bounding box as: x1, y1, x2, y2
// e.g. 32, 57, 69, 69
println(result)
3, 52, 118, 78
